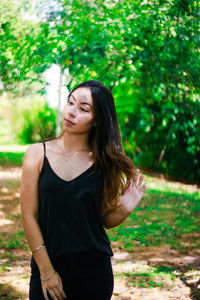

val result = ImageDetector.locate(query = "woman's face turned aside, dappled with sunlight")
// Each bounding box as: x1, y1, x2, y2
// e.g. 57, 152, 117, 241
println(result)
63, 87, 95, 133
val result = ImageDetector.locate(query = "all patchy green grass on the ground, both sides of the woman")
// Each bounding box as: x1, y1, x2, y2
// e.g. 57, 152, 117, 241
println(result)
0, 139, 200, 299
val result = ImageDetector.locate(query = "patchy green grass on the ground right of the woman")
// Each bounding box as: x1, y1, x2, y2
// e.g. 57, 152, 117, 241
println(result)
107, 176, 200, 299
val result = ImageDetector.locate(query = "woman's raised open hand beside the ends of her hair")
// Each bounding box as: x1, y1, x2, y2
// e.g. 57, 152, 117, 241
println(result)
120, 169, 146, 214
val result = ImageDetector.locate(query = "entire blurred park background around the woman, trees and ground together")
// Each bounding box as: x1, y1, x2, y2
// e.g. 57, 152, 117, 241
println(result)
0, 0, 200, 300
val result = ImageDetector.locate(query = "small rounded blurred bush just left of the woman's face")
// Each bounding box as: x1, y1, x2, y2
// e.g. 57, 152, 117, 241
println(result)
11, 98, 56, 143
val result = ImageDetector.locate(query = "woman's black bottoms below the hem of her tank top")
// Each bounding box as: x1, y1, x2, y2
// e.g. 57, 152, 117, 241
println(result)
29, 252, 114, 300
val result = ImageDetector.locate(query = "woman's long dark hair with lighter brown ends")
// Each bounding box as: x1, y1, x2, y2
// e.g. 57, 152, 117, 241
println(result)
68, 80, 135, 210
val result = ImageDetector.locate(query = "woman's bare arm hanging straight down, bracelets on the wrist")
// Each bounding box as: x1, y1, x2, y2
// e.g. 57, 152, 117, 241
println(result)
20, 144, 65, 299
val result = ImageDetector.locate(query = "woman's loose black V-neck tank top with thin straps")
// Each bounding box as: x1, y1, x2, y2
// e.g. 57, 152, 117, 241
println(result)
31, 143, 113, 266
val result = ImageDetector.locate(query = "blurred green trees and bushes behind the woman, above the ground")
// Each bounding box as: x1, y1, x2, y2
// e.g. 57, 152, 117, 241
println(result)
0, 0, 200, 183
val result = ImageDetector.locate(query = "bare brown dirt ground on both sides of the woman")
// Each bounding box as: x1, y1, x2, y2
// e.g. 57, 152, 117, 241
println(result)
0, 168, 200, 300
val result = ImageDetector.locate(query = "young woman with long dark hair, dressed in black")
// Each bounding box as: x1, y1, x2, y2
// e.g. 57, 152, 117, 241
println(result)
20, 80, 146, 300
